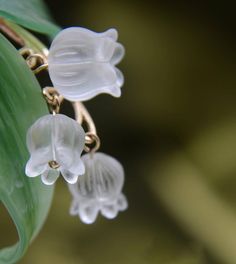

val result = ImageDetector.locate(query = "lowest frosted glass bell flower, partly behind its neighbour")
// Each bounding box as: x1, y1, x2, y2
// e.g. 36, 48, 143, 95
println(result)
69, 153, 128, 224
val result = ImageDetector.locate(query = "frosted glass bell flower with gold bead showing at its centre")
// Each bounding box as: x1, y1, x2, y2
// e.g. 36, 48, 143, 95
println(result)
25, 114, 85, 185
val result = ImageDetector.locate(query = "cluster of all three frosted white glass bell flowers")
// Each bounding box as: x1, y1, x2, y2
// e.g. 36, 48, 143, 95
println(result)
25, 27, 127, 224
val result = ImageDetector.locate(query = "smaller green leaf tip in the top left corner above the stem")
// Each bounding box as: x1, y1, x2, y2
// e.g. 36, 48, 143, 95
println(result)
0, 0, 60, 37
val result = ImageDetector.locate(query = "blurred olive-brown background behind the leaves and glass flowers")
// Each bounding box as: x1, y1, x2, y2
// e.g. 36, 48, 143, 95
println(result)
3, 0, 236, 264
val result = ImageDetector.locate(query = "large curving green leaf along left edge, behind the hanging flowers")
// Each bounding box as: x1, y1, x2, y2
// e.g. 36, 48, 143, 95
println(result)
0, 35, 53, 264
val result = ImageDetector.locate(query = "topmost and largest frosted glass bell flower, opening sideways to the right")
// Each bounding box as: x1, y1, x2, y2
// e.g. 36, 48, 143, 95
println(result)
48, 27, 124, 101
